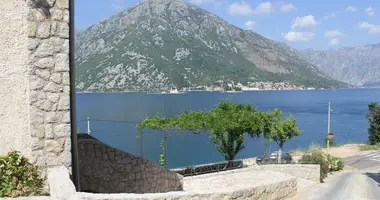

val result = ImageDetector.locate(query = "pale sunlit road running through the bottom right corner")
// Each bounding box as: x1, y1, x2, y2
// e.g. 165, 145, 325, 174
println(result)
291, 151, 380, 200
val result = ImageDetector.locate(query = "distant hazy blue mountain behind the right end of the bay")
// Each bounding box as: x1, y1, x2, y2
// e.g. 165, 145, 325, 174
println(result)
301, 43, 380, 86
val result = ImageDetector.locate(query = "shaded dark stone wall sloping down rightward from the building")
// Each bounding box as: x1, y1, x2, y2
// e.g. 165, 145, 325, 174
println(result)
78, 135, 183, 193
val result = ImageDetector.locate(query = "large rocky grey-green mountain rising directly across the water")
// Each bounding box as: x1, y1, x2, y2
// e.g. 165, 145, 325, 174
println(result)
75, 0, 344, 91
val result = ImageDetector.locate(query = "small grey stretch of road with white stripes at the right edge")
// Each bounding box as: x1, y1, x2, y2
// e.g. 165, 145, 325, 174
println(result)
344, 151, 380, 170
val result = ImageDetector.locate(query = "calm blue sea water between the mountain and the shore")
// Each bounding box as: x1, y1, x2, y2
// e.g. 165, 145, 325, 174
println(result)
77, 89, 380, 168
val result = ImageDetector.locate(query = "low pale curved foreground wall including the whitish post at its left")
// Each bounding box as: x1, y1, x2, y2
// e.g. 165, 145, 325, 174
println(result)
4, 166, 297, 200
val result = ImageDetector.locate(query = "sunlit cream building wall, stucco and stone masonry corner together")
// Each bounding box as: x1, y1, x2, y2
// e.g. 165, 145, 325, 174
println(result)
0, 0, 71, 177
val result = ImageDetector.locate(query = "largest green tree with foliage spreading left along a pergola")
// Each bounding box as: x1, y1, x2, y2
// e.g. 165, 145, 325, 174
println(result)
138, 100, 262, 164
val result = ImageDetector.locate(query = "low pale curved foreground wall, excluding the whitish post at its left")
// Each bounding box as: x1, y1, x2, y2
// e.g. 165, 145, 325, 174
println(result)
77, 169, 297, 200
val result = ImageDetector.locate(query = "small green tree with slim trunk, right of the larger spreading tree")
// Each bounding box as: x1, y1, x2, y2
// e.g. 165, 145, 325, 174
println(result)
262, 109, 301, 164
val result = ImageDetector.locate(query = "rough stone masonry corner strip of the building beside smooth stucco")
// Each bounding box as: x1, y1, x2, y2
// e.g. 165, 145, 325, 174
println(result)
26, 0, 71, 172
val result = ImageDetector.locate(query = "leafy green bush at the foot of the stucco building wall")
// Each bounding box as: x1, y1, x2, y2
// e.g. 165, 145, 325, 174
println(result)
0, 151, 44, 197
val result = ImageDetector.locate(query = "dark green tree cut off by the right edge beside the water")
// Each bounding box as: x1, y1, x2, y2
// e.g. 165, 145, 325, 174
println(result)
367, 103, 380, 145
